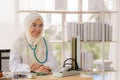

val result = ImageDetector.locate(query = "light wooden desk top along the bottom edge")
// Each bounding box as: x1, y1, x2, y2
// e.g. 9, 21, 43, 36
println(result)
19, 74, 93, 80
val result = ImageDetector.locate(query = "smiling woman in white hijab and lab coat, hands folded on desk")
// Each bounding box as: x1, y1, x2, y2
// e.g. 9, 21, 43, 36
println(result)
9, 12, 57, 73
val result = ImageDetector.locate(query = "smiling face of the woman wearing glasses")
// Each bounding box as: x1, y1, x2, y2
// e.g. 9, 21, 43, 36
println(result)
30, 19, 43, 38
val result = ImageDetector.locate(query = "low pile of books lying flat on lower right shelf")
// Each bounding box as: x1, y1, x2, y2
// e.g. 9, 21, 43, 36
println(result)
94, 60, 113, 71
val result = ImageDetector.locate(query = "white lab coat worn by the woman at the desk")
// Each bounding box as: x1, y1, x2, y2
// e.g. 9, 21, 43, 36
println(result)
9, 34, 57, 72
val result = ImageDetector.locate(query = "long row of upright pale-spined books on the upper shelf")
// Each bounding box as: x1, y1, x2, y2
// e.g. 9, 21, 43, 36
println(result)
64, 22, 112, 41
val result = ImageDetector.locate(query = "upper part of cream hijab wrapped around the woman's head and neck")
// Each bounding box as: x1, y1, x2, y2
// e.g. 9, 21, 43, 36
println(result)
24, 12, 44, 46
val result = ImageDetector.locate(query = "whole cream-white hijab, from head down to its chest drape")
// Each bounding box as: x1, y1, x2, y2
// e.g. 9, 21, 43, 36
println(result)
21, 12, 46, 65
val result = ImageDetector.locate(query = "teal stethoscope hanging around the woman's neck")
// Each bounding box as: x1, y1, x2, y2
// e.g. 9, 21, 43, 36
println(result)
29, 37, 48, 64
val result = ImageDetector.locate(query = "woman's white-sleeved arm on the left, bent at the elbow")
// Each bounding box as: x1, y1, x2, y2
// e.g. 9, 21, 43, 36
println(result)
9, 41, 30, 72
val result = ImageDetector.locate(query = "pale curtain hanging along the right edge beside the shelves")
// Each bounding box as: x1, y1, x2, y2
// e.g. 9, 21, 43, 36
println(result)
110, 0, 120, 80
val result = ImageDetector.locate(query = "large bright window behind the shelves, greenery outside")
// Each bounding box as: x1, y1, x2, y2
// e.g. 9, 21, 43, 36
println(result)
19, 0, 115, 80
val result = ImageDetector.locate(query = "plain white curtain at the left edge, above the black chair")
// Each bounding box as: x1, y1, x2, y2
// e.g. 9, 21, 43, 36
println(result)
0, 0, 16, 49
